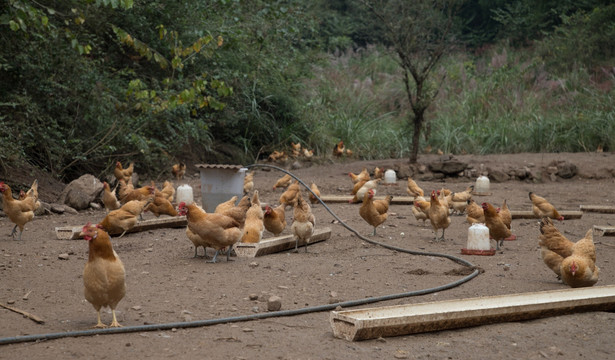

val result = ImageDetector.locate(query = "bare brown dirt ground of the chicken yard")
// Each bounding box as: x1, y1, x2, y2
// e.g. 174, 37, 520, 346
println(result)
0, 153, 615, 359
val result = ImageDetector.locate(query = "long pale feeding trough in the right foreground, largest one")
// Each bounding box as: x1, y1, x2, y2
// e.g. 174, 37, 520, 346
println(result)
329, 285, 615, 341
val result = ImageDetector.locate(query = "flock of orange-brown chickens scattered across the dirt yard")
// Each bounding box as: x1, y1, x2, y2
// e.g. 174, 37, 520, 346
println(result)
0, 155, 600, 328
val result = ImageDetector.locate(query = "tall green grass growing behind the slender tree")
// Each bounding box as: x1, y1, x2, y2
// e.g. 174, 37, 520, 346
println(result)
302, 46, 615, 159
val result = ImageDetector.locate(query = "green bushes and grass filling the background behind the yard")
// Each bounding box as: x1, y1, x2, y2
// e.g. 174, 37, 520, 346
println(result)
0, 0, 615, 180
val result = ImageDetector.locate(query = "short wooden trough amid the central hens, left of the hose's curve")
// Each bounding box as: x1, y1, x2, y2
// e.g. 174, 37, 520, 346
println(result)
233, 228, 331, 257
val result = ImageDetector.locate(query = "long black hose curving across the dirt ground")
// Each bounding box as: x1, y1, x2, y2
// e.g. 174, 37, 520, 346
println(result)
0, 164, 479, 345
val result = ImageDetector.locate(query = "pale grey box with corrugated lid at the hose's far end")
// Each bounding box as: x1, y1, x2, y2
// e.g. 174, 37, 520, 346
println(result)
196, 164, 248, 212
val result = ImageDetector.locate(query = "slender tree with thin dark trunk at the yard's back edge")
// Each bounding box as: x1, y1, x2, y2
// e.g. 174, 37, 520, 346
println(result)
363, 0, 459, 163
